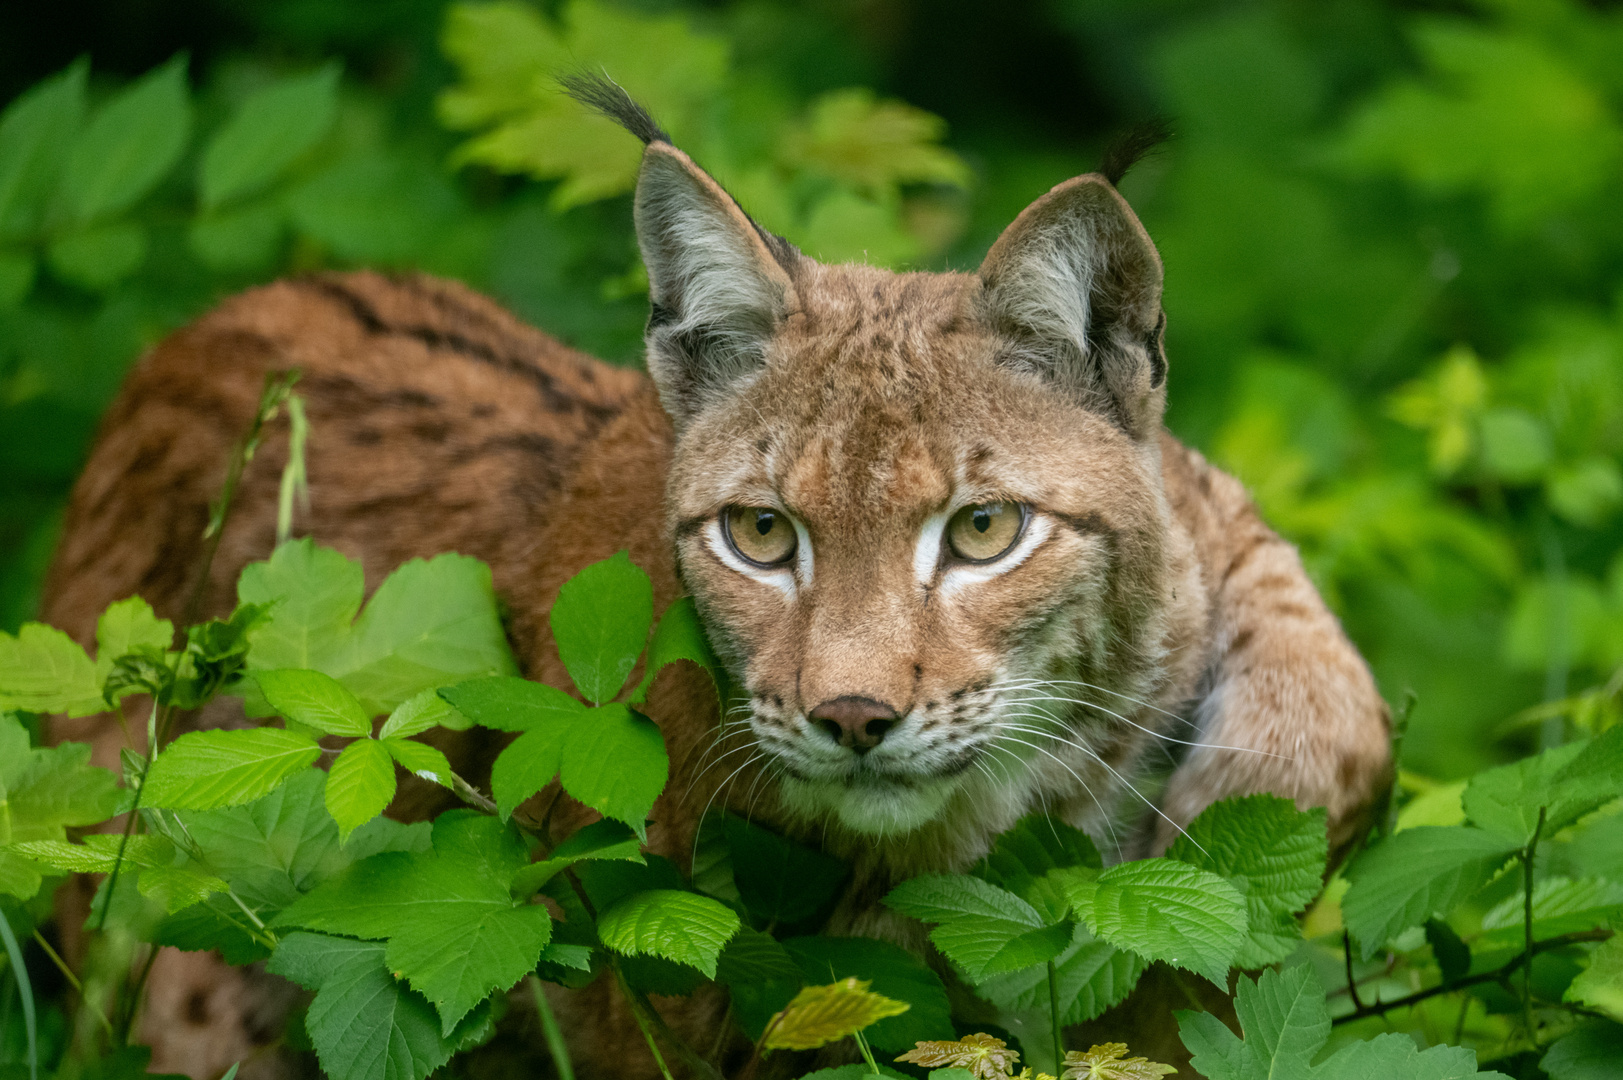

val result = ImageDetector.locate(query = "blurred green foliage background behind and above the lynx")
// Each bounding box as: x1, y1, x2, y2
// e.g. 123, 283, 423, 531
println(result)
0, 0, 1623, 784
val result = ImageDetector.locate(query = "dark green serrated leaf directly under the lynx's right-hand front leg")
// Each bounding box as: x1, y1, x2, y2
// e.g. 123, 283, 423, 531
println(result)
1167, 794, 1329, 968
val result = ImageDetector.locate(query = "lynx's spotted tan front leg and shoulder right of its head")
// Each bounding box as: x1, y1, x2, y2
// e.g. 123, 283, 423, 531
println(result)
1156, 451, 1391, 858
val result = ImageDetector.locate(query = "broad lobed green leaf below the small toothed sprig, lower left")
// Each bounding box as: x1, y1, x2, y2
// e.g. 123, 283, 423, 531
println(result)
276, 812, 552, 1035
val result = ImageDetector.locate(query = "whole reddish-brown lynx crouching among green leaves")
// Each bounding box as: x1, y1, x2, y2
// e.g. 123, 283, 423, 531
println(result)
44, 83, 1389, 1080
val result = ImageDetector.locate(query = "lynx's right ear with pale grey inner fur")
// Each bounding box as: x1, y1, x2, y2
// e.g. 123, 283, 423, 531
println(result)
980, 174, 1167, 438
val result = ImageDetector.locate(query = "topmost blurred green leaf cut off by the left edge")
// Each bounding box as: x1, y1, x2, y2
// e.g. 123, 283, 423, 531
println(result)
0, 60, 89, 237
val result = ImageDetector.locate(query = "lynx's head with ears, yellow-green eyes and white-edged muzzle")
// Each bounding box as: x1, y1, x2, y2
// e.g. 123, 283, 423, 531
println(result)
577, 79, 1170, 833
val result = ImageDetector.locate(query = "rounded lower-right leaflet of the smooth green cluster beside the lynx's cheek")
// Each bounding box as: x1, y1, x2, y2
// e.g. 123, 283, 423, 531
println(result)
558, 705, 658, 836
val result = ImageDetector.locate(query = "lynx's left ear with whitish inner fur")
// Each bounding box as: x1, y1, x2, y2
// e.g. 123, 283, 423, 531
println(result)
636, 141, 799, 429
